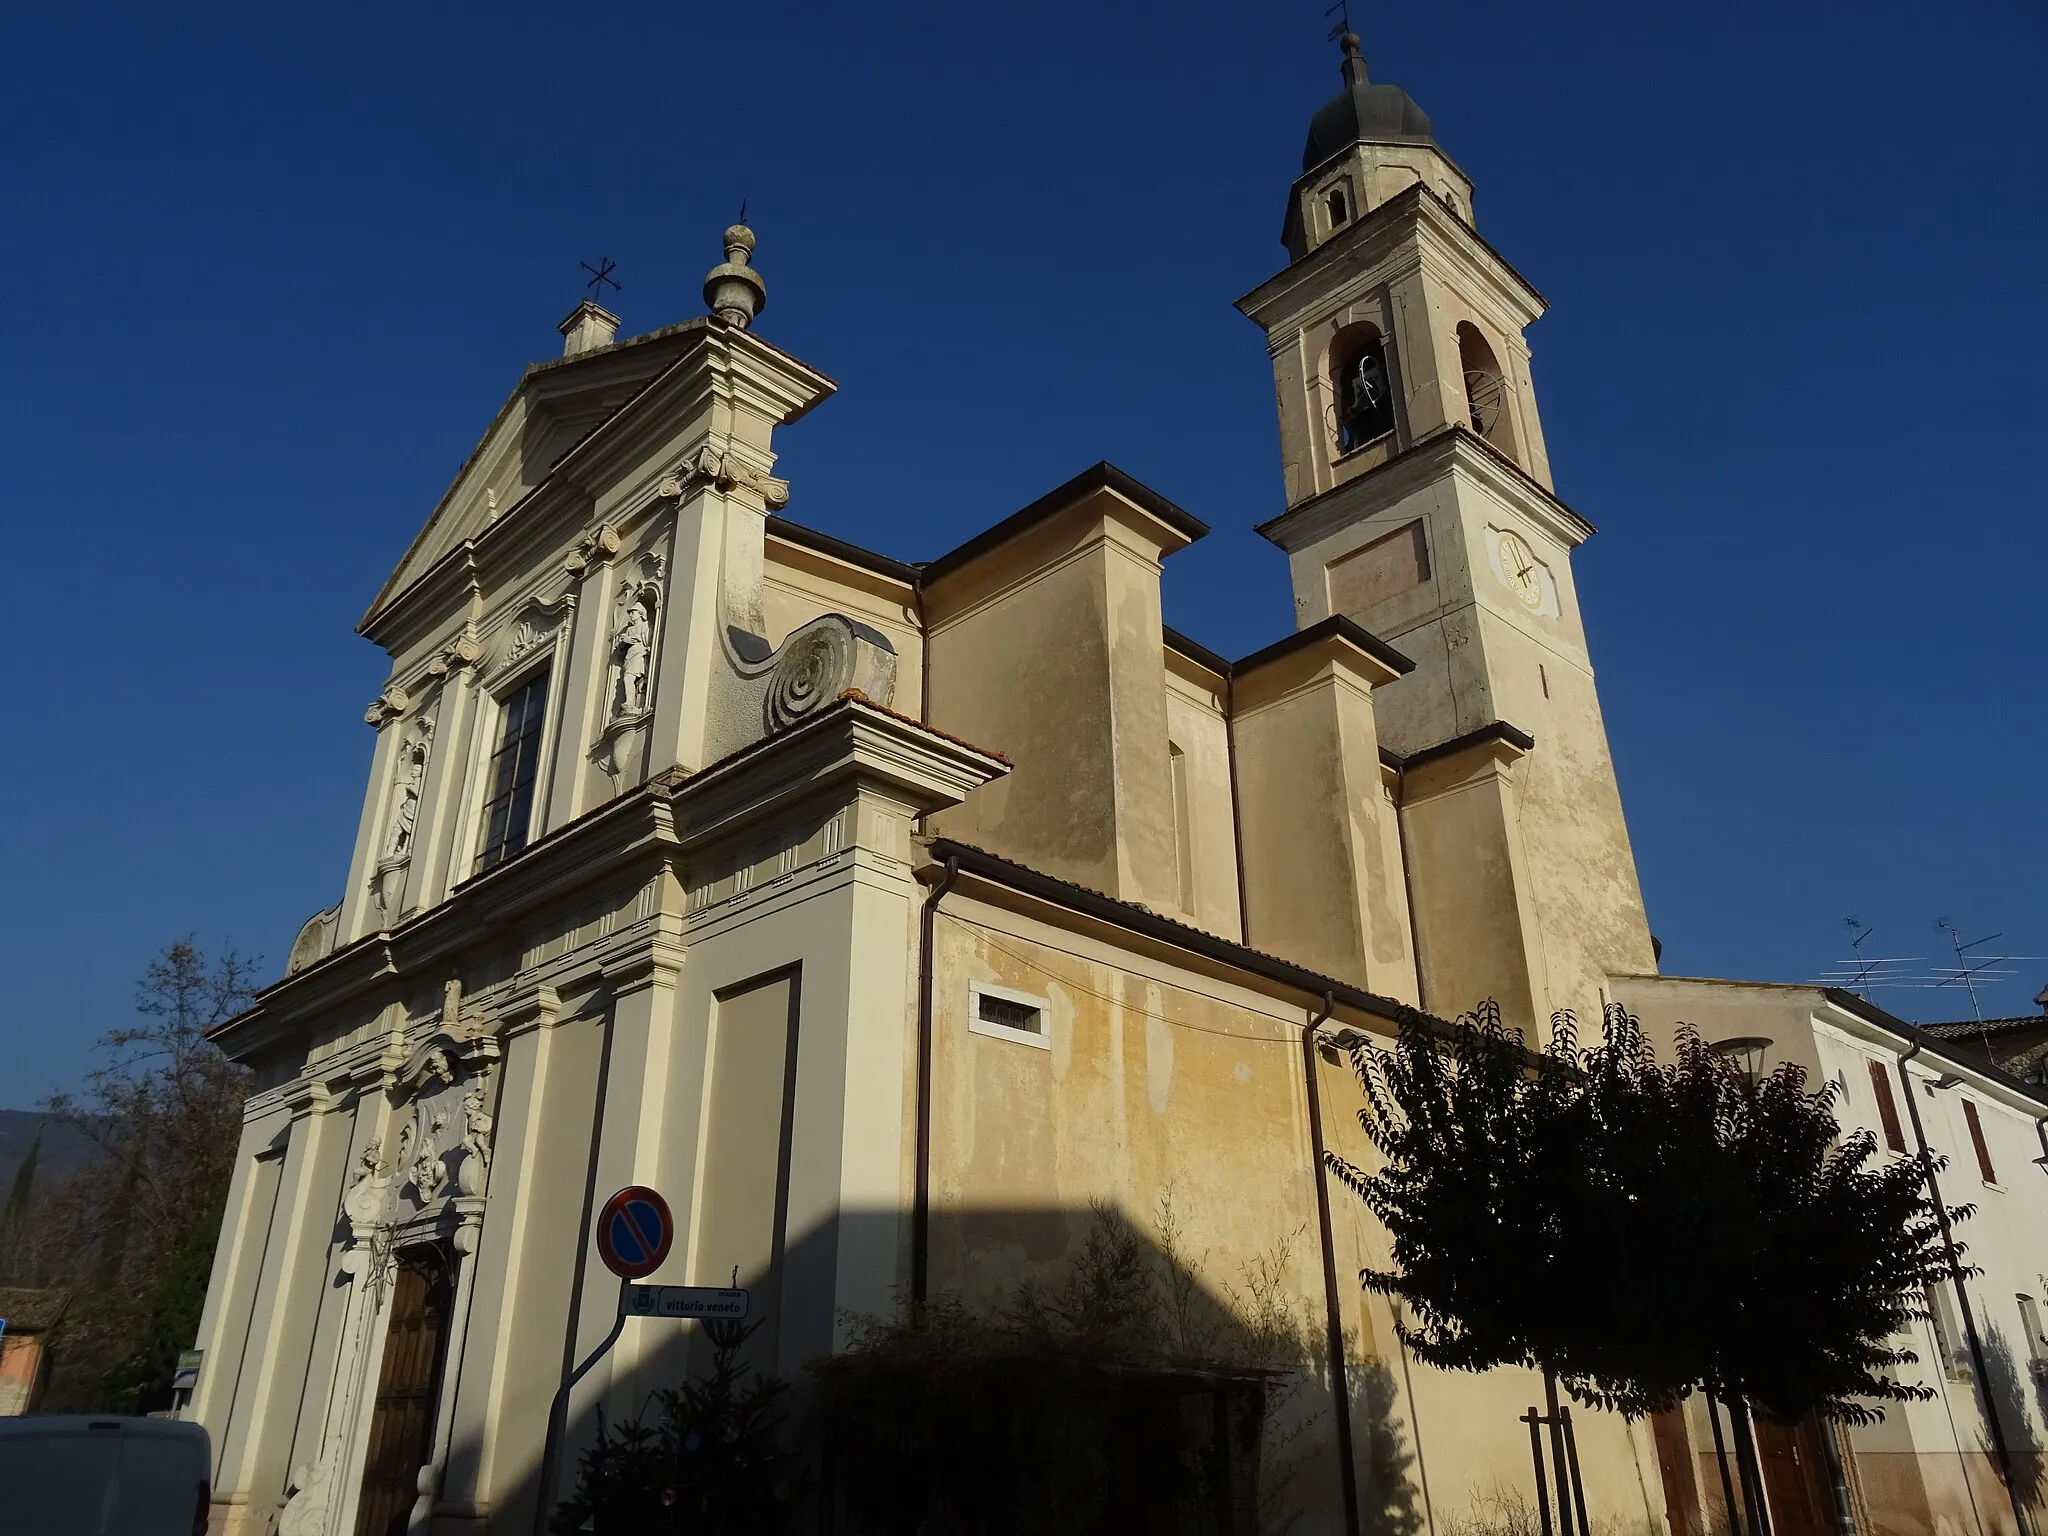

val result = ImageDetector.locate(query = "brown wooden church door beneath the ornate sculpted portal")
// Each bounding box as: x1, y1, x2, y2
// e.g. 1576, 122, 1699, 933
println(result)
356, 1247, 453, 1536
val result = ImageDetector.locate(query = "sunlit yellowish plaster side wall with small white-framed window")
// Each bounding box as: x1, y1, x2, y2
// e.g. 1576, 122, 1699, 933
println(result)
932, 893, 1661, 1536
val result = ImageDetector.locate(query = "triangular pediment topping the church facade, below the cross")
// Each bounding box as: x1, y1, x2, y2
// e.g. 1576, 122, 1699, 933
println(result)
362, 319, 707, 629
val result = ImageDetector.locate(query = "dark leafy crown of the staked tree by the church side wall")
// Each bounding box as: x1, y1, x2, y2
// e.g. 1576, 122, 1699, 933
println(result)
1329, 1004, 1970, 1531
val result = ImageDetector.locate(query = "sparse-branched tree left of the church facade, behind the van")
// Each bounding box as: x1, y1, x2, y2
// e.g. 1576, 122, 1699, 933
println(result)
35, 940, 256, 1411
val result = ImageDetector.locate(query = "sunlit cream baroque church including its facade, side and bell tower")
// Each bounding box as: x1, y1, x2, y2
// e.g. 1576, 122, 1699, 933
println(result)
186, 37, 2039, 1536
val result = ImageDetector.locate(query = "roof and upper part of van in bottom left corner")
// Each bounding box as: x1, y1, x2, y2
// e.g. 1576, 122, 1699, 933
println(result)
0, 1413, 213, 1536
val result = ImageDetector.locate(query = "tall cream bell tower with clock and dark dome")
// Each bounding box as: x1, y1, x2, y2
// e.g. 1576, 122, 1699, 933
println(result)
1237, 33, 1655, 1022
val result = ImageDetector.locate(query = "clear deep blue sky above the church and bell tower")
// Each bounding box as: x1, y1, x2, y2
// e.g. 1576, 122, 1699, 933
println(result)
0, 0, 2048, 1106
